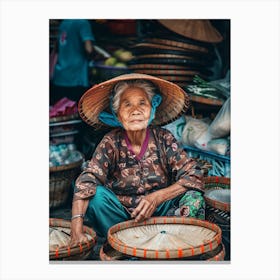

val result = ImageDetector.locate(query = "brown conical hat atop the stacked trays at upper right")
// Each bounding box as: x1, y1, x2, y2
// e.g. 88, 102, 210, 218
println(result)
159, 19, 223, 43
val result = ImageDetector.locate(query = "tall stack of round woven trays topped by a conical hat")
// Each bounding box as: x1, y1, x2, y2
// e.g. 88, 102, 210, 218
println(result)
129, 20, 222, 86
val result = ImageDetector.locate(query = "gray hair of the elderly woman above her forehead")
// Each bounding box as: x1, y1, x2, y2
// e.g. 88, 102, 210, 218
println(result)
112, 80, 155, 113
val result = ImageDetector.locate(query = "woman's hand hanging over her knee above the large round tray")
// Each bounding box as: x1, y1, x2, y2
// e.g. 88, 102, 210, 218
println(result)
131, 192, 160, 222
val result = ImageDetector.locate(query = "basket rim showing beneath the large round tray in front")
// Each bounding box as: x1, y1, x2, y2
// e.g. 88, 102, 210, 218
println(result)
99, 243, 225, 261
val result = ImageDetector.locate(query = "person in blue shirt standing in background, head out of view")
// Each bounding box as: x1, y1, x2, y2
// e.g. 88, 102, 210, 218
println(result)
50, 19, 95, 105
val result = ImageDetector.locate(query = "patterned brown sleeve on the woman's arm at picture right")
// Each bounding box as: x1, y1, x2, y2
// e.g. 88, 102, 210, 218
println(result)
163, 129, 204, 192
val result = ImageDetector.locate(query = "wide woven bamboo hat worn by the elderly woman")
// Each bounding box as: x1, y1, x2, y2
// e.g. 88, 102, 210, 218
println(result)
78, 73, 190, 128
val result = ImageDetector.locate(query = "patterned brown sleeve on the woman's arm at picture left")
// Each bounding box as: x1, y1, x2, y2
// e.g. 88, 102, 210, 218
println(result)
73, 137, 114, 201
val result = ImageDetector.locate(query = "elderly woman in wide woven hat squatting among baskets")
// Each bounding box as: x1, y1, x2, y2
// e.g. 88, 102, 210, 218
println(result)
71, 74, 205, 245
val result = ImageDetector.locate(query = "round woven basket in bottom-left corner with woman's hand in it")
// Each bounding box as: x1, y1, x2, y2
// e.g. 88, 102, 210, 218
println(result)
49, 218, 97, 260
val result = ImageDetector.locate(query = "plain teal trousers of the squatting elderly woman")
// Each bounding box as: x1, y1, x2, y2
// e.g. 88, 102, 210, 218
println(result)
86, 186, 181, 238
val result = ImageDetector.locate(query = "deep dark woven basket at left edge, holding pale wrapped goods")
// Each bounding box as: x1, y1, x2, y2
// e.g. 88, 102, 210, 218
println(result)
49, 156, 84, 209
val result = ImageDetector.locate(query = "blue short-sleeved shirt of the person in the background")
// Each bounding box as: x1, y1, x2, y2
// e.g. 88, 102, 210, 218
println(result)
53, 19, 94, 87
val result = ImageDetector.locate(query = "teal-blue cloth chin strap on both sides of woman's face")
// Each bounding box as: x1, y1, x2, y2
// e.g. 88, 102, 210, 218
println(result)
98, 94, 162, 127
